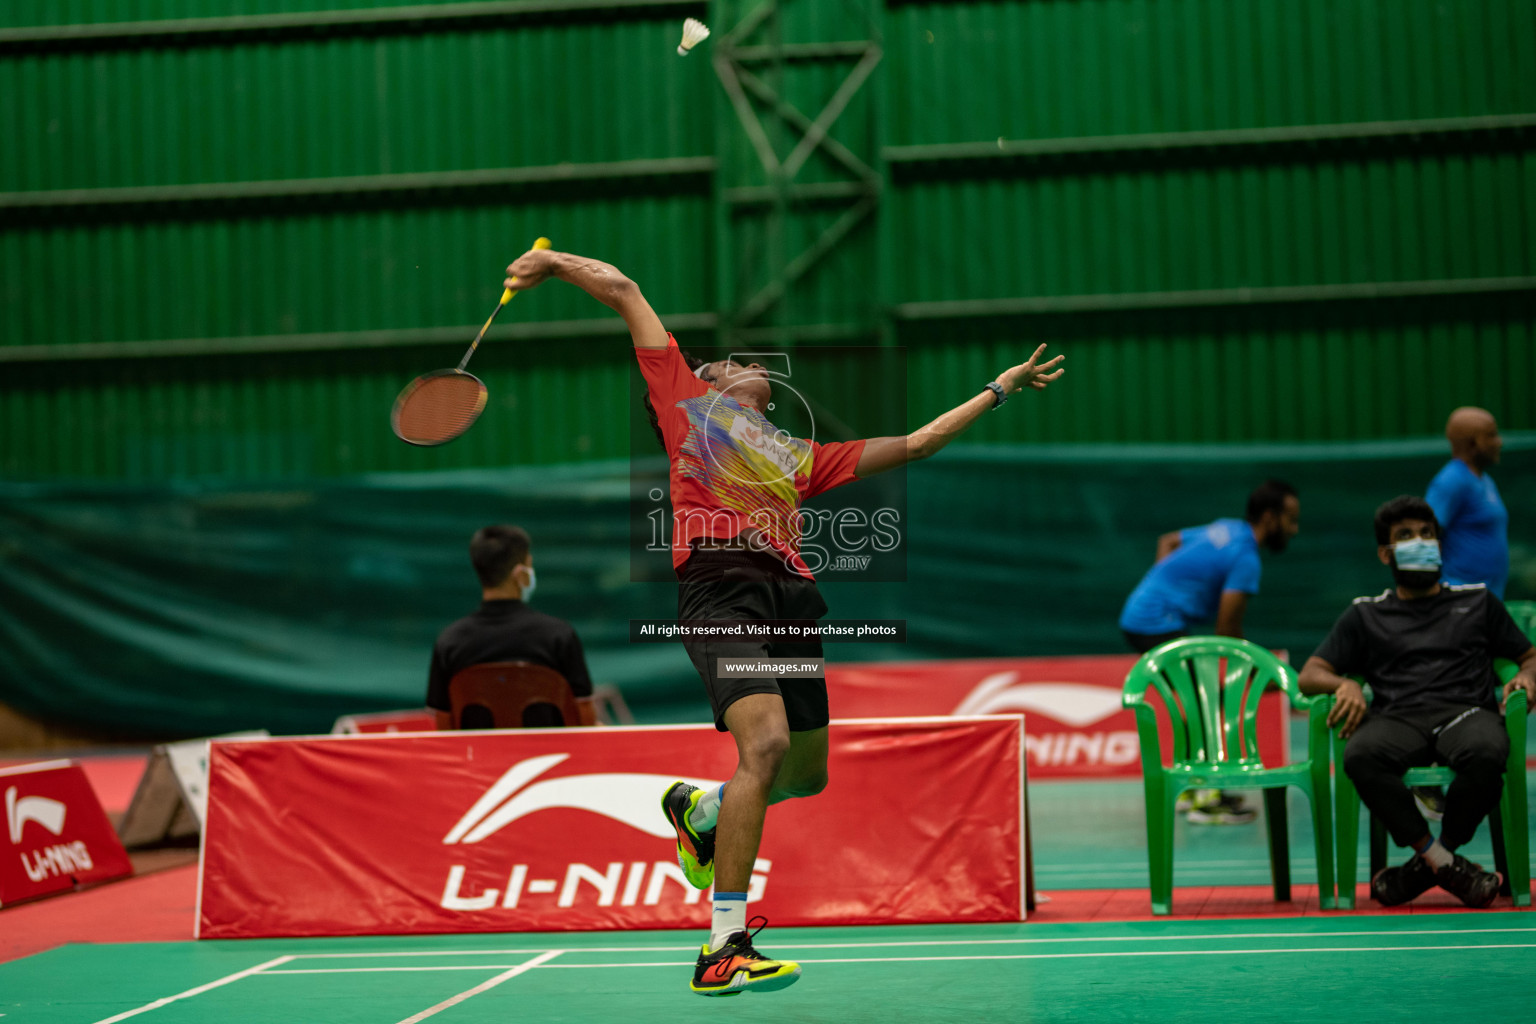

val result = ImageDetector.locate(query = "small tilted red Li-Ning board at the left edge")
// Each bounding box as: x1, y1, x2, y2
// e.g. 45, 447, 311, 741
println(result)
0, 761, 134, 906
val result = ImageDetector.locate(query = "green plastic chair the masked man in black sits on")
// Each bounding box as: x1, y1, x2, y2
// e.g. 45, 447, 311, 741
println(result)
1329, 659, 1531, 910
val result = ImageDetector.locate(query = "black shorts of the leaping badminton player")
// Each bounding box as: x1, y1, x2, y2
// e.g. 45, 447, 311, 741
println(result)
677, 548, 829, 732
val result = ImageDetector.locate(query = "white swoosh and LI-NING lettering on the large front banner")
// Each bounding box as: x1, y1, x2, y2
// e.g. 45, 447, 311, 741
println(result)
438, 754, 761, 910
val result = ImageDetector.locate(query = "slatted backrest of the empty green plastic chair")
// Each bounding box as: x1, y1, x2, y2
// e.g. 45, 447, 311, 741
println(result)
1121, 637, 1307, 765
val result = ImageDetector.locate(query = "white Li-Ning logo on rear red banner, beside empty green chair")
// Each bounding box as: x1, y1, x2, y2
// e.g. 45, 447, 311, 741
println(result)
954, 672, 1140, 768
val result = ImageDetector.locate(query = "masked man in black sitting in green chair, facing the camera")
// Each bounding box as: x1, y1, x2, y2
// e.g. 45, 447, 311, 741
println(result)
1301, 496, 1536, 907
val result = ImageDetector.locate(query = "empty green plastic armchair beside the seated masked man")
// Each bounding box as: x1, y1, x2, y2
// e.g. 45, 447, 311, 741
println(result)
1121, 637, 1333, 913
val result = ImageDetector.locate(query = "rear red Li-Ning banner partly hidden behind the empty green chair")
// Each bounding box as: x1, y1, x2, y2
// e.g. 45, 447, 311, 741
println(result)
826, 654, 1290, 780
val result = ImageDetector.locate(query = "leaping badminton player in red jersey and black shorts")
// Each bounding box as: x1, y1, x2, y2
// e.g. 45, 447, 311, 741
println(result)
507, 249, 1061, 995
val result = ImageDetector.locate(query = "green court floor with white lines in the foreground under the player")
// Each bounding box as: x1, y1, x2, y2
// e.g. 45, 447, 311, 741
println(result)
0, 912, 1536, 1024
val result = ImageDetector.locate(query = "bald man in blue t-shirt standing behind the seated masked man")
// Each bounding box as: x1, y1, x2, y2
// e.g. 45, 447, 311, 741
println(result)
1425, 405, 1510, 600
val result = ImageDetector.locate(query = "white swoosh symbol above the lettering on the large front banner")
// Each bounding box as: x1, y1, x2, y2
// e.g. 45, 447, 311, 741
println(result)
442, 754, 720, 846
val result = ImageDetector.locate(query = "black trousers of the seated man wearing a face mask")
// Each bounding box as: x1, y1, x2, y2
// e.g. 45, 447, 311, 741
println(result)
1344, 706, 1510, 849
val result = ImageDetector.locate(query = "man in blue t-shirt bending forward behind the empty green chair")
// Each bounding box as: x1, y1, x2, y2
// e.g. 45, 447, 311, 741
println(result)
1120, 481, 1301, 824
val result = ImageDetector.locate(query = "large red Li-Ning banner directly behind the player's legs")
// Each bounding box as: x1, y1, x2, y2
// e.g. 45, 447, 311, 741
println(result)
197, 715, 1025, 938
